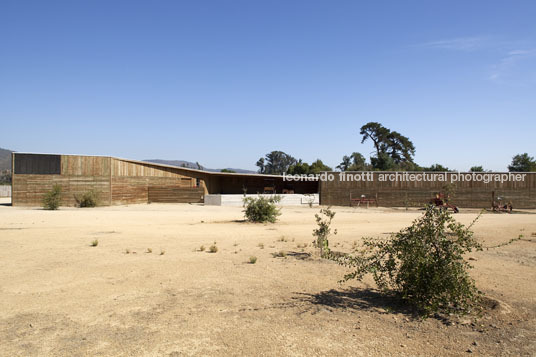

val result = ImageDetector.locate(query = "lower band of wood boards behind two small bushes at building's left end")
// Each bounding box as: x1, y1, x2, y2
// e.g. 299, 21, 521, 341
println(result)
12, 175, 110, 207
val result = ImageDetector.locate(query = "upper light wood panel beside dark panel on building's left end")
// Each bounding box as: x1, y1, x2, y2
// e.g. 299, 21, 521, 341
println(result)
61, 155, 111, 176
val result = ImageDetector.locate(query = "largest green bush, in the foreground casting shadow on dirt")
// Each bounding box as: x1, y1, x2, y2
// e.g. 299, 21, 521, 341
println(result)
330, 206, 482, 316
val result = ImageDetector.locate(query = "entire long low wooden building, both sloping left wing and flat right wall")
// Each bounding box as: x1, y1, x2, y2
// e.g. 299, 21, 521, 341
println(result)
12, 153, 536, 208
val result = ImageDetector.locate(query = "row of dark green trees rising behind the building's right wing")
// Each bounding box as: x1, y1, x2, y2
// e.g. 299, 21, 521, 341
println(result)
256, 122, 536, 175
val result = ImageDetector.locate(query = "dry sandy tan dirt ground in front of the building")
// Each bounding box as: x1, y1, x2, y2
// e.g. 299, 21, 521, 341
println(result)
0, 199, 536, 356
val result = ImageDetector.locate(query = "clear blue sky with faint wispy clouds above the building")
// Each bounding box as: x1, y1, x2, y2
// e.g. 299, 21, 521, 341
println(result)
0, 0, 536, 170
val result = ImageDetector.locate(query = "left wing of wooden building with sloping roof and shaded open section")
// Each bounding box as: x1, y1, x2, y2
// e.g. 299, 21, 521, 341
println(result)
12, 153, 318, 206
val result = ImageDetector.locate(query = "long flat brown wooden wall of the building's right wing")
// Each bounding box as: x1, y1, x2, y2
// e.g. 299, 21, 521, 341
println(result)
320, 172, 536, 208
